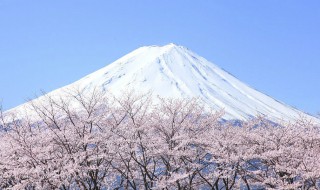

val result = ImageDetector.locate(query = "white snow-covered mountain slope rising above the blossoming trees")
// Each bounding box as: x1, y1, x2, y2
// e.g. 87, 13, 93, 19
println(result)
7, 44, 315, 121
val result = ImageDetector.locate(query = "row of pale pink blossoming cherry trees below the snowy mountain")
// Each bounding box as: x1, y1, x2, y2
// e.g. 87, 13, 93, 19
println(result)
0, 91, 320, 190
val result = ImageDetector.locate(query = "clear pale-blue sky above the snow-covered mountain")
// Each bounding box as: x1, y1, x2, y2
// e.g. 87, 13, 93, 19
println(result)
0, 0, 320, 114
